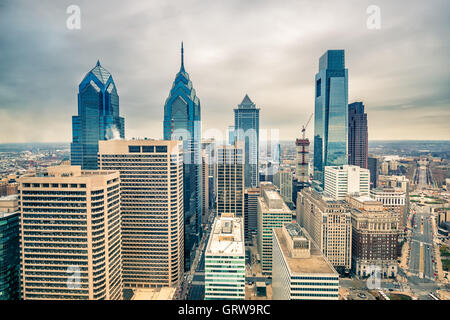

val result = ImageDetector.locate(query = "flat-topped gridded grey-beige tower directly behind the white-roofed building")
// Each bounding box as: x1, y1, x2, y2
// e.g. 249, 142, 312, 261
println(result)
216, 141, 244, 218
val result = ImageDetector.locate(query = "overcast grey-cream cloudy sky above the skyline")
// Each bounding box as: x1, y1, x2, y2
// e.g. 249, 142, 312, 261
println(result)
0, 0, 450, 143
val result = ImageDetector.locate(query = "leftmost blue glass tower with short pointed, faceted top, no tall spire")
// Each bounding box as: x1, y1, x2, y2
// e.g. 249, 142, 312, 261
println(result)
70, 61, 125, 170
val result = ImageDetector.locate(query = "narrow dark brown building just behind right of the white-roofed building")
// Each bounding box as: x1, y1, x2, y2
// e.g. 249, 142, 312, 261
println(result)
244, 188, 261, 245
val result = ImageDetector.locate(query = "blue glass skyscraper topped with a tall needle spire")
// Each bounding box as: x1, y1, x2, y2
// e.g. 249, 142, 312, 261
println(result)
164, 43, 202, 270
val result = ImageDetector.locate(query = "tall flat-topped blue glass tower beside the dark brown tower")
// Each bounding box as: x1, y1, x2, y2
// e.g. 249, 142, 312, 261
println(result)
314, 50, 348, 185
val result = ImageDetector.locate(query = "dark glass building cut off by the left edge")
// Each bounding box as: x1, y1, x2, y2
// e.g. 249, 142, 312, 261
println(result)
0, 195, 20, 300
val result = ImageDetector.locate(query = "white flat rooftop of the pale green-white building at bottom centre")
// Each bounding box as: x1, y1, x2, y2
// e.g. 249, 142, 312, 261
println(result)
206, 216, 244, 255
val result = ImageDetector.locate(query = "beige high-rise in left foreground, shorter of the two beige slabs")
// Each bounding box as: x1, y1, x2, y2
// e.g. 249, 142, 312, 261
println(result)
19, 166, 123, 300
